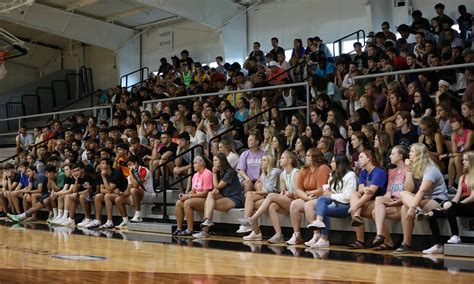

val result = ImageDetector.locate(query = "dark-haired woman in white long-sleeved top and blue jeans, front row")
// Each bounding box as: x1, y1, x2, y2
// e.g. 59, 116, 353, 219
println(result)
308, 154, 357, 248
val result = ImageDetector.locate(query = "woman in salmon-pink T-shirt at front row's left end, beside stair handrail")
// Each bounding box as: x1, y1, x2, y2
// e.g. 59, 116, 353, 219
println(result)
173, 156, 213, 236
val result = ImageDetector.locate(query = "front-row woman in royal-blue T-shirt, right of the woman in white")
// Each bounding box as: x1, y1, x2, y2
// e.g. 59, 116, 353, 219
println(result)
349, 150, 388, 249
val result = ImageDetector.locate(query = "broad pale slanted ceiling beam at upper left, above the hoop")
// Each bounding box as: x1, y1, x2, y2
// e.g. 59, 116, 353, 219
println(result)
0, 3, 137, 50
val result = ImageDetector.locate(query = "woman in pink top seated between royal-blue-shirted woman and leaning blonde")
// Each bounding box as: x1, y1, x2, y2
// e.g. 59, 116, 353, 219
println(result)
372, 145, 408, 250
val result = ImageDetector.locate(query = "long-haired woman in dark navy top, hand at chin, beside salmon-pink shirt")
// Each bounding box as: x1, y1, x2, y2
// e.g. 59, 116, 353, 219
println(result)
193, 152, 244, 238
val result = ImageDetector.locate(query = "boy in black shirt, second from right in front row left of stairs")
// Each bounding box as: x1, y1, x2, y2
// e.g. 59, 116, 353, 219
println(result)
86, 159, 128, 229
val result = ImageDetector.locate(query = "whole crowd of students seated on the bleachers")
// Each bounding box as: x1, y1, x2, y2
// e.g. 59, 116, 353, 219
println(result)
0, 4, 474, 253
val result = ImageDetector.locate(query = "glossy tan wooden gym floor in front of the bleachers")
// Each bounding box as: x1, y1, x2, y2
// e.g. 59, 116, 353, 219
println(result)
0, 220, 474, 284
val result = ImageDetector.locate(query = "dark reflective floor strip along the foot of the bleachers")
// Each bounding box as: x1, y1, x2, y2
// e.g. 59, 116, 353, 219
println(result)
0, 219, 474, 272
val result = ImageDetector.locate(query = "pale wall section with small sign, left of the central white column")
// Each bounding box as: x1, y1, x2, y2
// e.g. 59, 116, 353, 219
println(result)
141, 21, 224, 71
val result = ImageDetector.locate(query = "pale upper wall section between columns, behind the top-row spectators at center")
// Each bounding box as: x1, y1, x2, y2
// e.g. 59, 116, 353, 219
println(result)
247, 0, 370, 52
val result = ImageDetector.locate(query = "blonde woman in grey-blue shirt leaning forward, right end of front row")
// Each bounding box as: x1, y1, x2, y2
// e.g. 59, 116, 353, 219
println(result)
395, 143, 448, 253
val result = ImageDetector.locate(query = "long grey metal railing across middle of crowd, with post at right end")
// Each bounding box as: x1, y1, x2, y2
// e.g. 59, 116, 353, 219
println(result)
142, 82, 311, 123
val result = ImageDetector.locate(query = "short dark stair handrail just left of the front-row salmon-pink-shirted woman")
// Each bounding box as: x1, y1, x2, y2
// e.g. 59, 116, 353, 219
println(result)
153, 144, 204, 220
